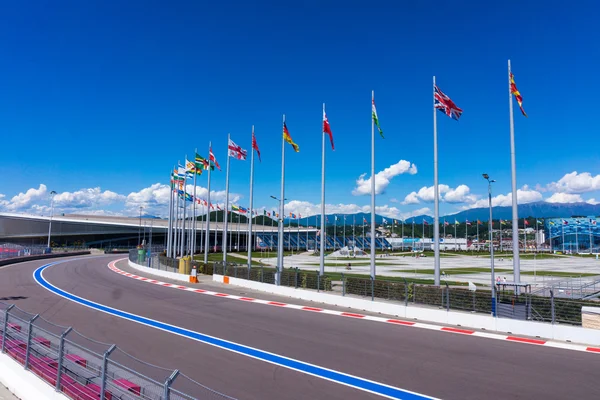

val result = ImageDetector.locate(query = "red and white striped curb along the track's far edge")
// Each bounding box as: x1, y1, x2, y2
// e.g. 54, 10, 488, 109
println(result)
108, 258, 600, 354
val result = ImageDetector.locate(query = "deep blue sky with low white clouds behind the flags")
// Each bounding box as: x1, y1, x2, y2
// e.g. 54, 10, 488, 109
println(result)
0, 0, 600, 217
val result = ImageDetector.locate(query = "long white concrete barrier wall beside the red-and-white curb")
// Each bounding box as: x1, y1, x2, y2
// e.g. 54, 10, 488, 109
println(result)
213, 275, 600, 346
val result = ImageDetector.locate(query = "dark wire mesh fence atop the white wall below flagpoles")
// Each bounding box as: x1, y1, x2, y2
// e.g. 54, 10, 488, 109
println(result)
210, 262, 600, 326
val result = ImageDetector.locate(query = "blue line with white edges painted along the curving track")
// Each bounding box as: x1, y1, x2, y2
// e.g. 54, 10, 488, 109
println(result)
33, 259, 435, 400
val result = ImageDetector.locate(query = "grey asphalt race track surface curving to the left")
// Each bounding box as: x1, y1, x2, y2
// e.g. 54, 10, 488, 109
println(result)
0, 255, 600, 400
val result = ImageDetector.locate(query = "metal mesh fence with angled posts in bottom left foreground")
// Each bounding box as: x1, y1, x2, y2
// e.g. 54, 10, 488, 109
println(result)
0, 302, 233, 400
